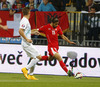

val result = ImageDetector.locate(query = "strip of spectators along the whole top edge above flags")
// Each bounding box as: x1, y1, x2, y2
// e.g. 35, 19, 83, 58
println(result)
0, 0, 100, 14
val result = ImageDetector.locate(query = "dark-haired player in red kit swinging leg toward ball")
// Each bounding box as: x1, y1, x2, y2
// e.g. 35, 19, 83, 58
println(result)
33, 18, 76, 74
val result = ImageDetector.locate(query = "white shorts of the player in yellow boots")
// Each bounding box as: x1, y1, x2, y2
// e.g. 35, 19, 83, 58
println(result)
22, 45, 40, 58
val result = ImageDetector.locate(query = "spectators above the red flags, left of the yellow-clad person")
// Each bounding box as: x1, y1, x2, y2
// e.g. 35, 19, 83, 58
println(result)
0, 0, 66, 15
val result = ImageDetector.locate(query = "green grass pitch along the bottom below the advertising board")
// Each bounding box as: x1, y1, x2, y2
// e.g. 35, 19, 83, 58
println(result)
0, 73, 100, 87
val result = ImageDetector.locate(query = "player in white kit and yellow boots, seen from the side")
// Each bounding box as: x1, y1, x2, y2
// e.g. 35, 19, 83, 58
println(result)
19, 7, 48, 80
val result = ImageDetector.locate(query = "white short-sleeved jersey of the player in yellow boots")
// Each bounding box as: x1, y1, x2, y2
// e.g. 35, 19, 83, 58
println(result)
20, 17, 31, 47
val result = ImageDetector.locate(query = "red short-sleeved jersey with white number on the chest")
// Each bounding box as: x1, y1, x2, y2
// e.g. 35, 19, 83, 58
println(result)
39, 24, 63, 50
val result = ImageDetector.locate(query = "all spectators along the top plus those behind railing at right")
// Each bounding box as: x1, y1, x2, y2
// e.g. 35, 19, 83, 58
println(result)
0, 0, 100, 46
